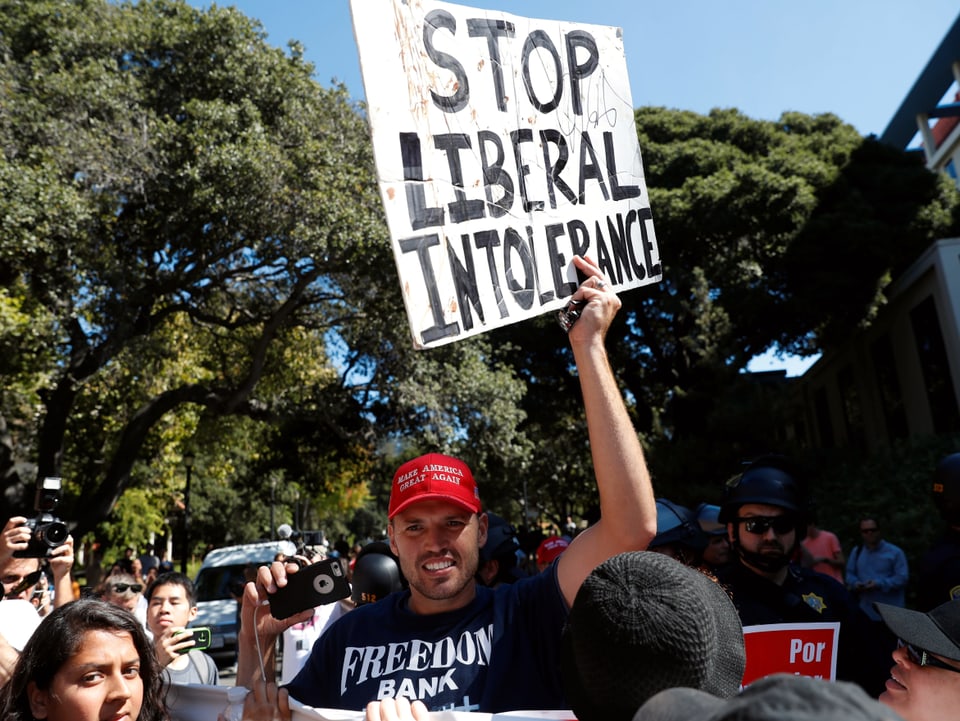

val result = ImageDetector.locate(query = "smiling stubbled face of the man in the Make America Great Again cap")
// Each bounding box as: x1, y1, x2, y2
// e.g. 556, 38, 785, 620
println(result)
387, 501, 487, 613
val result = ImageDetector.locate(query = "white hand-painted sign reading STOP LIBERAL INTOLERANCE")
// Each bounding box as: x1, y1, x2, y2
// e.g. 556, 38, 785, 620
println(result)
351, 0, 661, 348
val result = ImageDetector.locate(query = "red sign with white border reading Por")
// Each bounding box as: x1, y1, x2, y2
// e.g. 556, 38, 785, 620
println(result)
743, 622, 840, 686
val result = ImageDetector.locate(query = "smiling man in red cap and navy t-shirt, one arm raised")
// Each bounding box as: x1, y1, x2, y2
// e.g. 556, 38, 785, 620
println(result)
237, 256, 657, 713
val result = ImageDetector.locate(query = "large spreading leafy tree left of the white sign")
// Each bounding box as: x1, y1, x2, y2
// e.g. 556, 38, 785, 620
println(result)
0, 0, 392, 532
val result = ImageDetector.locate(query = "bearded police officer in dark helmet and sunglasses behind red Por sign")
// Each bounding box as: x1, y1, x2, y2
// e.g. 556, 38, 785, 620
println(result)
717, 456, 889, 696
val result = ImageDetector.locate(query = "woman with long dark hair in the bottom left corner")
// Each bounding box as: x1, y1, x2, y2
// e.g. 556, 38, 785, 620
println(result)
0, 598, 169, 721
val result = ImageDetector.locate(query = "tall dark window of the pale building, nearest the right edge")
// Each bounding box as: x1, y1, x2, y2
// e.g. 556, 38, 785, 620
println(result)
910, 296, 960, 433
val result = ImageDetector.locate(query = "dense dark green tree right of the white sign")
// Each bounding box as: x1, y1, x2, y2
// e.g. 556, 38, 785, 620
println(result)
624, 108, 957, 494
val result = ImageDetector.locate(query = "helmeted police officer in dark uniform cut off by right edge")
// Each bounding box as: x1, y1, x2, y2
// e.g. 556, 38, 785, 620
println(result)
917, 453, 960, 611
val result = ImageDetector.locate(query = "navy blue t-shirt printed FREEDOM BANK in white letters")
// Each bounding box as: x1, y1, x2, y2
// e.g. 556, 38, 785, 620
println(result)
287, 563, 568, 713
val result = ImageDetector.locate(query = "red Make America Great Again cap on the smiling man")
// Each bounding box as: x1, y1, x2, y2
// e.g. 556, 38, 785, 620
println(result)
387, 453, 480, 518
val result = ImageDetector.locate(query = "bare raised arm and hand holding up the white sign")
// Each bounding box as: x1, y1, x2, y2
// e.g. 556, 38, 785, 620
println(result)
557, 257, 657, 605
